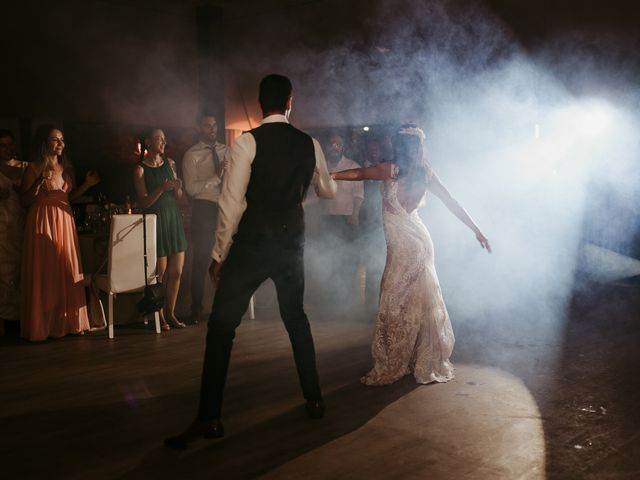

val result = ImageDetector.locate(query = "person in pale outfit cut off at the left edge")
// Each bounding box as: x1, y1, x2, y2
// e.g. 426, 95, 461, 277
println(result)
0, 129, 28, 322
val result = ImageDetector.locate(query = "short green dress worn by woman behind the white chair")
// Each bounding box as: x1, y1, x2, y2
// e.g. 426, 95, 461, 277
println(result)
140, 160, 187, 257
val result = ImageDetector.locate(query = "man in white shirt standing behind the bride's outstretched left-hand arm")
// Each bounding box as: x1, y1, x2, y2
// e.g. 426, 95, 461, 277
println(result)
320, 133, 364, 309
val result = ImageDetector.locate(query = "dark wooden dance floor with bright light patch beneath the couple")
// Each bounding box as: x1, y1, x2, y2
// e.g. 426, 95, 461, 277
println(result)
0, 287, 640, 479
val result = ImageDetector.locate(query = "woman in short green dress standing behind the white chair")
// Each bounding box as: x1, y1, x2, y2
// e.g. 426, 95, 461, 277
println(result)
133, 129, 187, 330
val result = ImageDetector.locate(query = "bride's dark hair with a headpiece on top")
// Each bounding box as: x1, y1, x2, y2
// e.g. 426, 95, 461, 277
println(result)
391, 123, 431, 187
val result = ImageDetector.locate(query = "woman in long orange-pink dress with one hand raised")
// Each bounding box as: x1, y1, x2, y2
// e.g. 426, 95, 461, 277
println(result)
20, 125, 100, 341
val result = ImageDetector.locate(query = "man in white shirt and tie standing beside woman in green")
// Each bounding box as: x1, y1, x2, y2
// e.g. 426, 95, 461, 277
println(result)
182, 114, 227, 323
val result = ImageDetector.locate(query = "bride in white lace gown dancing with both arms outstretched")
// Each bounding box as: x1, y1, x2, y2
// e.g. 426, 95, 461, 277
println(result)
331, 124, 491, 385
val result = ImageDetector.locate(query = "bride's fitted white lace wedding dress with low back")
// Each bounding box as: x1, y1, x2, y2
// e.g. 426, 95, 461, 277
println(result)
362, 180, 455, 385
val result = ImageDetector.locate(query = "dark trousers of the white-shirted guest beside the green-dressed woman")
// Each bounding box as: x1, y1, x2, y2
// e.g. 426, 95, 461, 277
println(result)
191, 200, 218, 313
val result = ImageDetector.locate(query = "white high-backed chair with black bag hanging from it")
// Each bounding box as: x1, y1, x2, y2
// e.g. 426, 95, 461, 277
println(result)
95, 214, 160, 338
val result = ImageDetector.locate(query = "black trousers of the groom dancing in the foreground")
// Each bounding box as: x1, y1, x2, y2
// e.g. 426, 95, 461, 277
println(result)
198, 232, 322, 420
